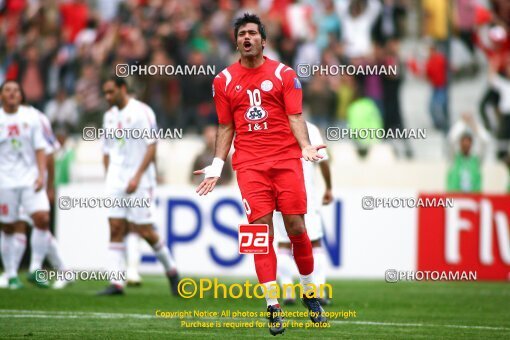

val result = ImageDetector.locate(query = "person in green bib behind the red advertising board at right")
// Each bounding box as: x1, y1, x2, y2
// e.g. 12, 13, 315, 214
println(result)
446, 132, 482, 192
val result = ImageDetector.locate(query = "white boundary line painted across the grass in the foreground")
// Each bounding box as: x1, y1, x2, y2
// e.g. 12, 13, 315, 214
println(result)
0, 309, 510, 331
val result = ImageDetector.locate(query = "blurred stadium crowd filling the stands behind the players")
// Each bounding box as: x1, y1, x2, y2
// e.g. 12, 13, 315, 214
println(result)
0, 0, 510, 190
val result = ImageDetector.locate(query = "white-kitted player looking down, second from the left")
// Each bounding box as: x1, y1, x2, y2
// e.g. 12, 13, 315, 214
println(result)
99, 78, 179, 295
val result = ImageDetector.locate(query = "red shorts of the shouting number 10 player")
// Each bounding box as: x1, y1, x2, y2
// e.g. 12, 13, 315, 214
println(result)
236, 158, 306, 223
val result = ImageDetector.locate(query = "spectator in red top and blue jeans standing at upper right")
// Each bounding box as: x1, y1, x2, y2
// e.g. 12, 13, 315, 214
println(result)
426, 43, 449, 134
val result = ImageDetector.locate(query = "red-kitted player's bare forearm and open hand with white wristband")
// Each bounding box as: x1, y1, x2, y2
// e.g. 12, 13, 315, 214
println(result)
193, 123, 234, 196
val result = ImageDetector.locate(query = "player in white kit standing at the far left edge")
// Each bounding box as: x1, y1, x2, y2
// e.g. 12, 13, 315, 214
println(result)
0, 80, 63, 289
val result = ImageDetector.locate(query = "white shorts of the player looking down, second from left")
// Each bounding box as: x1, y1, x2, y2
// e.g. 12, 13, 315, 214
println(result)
107, 188, 154, 224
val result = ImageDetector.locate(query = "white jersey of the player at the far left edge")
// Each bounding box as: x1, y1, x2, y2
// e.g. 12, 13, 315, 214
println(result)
0, 106, 48, 189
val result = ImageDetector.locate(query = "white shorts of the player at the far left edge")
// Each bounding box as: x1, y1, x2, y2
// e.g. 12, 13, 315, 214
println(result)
0, 187, 50, 223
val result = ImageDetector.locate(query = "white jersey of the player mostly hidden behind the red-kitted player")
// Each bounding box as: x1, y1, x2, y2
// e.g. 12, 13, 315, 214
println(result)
301, 122, 329, 214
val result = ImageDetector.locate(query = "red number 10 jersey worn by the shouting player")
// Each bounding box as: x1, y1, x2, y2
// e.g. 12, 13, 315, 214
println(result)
213, 57, 303, 170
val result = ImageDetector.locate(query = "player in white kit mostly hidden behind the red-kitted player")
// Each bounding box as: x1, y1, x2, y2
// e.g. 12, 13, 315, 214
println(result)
273, 122, 333, 305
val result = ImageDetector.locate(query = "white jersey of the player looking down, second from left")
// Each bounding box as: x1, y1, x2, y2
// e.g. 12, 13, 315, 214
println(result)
103, 98, 156, 190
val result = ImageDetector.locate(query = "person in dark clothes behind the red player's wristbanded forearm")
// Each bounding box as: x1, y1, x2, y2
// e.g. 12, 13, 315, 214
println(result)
190, 125, 232, 185
